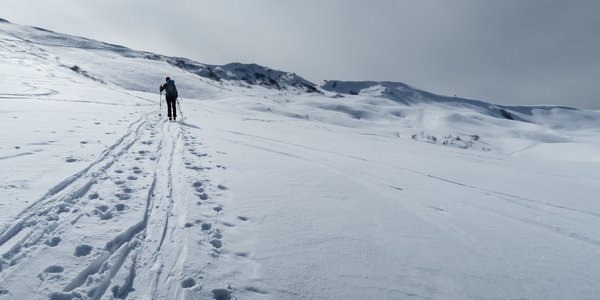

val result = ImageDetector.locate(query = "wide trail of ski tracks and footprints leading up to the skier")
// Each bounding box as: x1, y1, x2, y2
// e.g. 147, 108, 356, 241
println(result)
0, 112, 238, 299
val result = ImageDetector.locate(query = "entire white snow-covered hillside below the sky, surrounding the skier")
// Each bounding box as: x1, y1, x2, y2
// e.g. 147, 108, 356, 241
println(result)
0, 22, 600, 299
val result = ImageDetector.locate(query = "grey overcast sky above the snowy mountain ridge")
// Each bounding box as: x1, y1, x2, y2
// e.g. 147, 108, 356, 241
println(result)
0, 0, 600, 109
